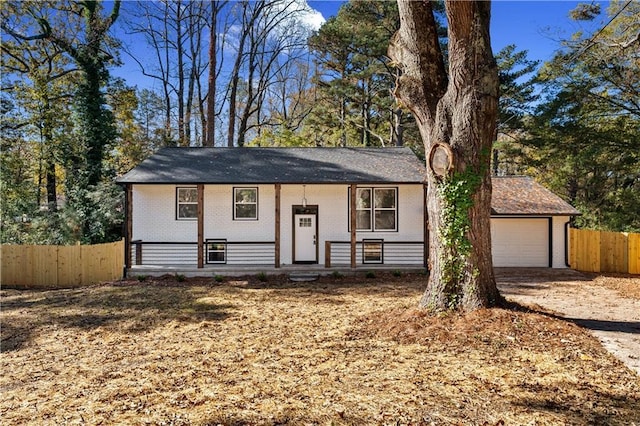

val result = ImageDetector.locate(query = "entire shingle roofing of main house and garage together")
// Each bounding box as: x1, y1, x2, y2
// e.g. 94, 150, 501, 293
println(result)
118, 148, 580, 216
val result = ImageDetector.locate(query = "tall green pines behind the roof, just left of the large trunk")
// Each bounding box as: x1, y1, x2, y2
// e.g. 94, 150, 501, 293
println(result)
305, 0, 422, 146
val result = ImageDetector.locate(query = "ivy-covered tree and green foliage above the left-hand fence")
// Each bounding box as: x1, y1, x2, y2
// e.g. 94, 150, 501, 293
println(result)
0, 1, 126, 244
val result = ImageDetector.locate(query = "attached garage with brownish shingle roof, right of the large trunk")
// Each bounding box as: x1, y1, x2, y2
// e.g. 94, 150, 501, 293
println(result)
491, 176, 580, 268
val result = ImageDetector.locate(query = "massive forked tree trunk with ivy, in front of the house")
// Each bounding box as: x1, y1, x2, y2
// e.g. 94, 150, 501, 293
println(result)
389, 0, 500, 311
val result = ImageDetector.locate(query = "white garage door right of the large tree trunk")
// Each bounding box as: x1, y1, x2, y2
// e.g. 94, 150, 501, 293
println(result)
491, 218, 549, 267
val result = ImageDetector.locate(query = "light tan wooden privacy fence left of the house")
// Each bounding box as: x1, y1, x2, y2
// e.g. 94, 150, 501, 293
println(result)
0, 240, 124, 288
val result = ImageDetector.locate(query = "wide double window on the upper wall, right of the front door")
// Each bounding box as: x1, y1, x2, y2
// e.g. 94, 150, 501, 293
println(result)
356, 188, 398, 231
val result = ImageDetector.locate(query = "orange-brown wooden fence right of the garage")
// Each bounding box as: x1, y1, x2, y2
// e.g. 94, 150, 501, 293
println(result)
569, 229, 640, 274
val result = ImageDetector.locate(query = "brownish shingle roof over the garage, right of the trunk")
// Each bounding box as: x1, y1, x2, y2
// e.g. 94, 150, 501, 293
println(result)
491, 176, 580, 216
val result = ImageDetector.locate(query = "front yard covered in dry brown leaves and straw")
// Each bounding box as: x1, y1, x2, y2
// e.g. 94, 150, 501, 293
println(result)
0, 274, 640, 425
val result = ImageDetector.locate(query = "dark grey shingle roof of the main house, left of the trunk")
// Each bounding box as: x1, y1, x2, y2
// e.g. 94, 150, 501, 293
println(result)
118, 148, 425, 184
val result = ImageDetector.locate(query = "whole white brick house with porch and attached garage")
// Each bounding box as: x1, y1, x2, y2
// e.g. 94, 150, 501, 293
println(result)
118, 148, 578, 275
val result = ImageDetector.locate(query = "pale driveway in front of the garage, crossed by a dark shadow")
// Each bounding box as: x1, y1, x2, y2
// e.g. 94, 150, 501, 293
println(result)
496, 269, 640, 375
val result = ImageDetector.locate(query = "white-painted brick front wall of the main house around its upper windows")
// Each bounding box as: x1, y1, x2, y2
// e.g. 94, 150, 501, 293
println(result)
132, 184, 424, 264
